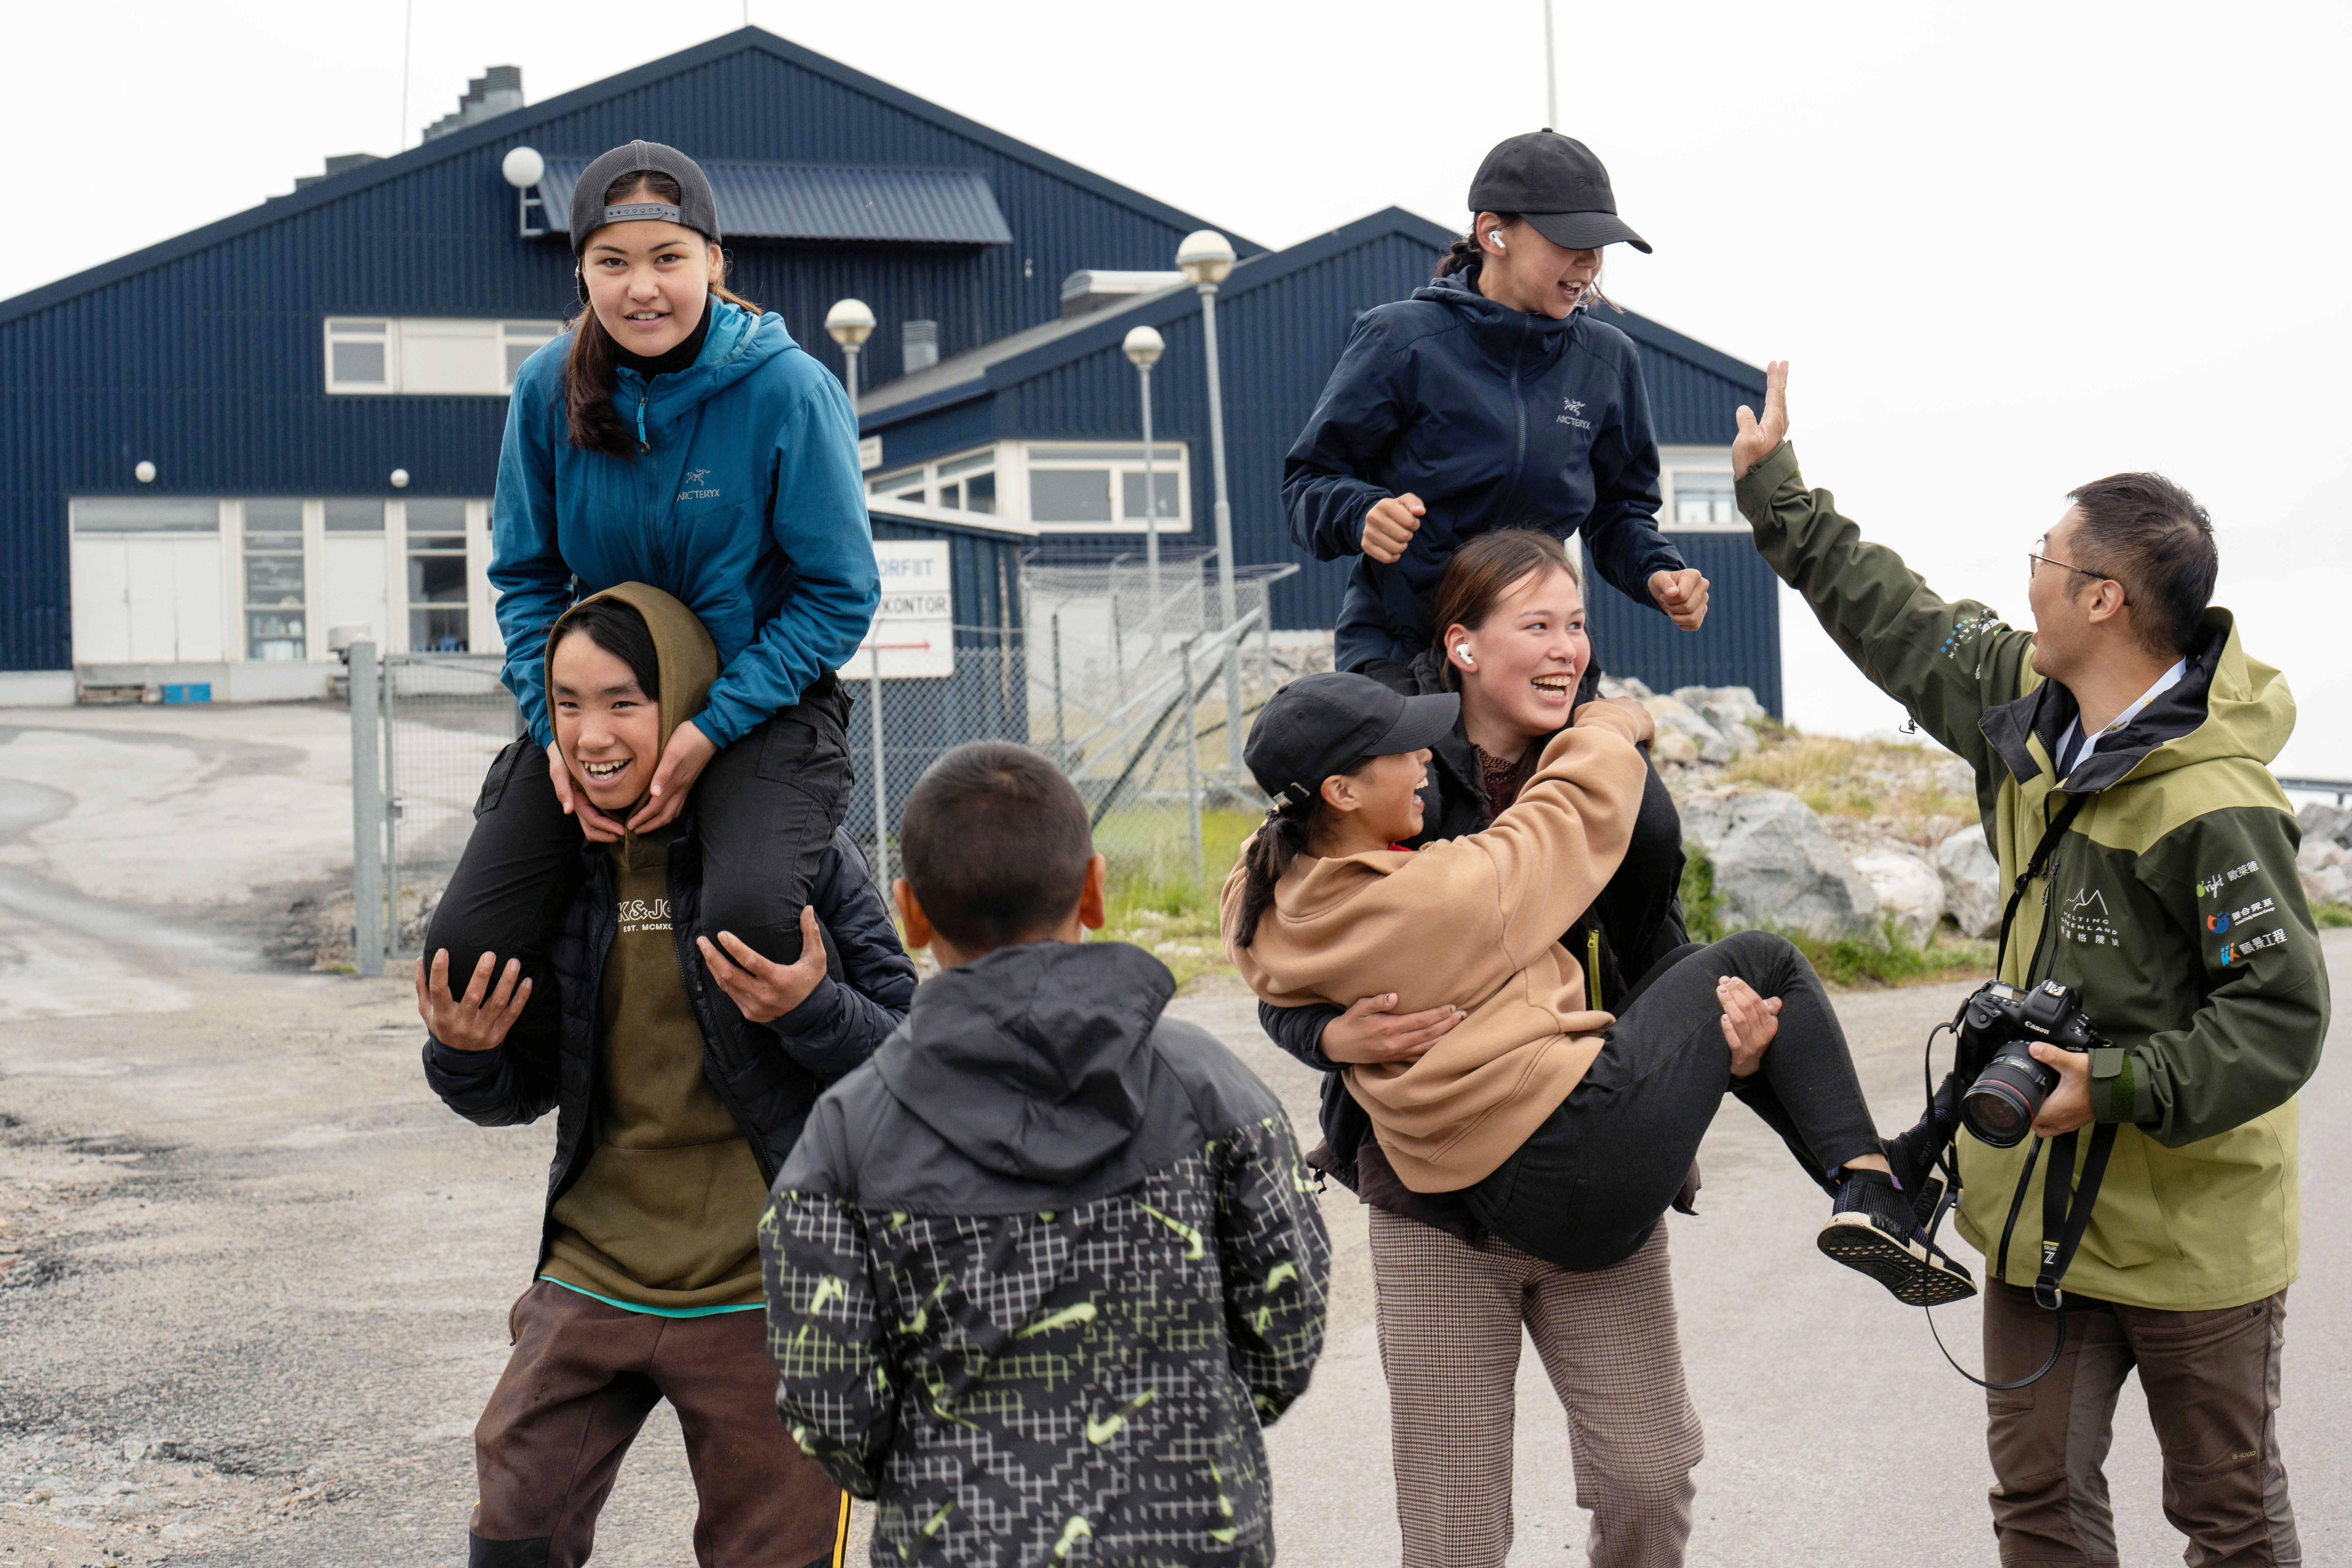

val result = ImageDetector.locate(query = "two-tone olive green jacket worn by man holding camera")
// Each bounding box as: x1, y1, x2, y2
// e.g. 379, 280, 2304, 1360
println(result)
1738, 442, 2329, 1312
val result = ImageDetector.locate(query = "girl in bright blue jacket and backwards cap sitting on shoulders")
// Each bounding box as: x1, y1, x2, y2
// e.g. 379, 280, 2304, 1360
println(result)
426, 141, 880, 982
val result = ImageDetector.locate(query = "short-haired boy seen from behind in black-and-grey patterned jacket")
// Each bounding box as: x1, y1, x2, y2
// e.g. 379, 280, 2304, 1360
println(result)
760, 743, 1329, 1568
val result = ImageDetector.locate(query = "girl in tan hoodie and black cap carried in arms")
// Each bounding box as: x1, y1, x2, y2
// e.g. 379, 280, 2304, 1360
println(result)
1223, 675, 1973, 1302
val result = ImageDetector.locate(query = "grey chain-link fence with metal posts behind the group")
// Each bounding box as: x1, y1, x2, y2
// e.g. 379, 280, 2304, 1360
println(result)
350, 548, 1329, 973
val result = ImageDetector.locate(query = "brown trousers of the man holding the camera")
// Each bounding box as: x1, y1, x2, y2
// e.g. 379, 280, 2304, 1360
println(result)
1985, 1279, 2303, 1568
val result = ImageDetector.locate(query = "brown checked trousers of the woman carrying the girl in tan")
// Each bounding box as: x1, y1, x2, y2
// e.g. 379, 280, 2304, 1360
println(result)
1369, 1208, 1705, 1568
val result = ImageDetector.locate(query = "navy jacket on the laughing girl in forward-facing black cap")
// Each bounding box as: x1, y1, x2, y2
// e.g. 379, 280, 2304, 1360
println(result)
1282, 273, 1682, 670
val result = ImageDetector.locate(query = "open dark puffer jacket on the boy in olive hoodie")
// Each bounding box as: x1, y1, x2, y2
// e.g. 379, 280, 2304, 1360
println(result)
426, 823, 915, 1258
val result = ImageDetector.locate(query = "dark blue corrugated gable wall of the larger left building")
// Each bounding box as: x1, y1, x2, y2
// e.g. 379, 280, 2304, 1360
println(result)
0, 35, 1256, 670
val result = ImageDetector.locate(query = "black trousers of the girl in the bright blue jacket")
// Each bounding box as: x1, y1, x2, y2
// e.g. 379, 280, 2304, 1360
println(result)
426, 675, 851, 973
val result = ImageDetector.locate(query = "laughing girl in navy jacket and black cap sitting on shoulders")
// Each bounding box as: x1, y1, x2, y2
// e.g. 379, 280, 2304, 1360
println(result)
1282, 129, 1708, 670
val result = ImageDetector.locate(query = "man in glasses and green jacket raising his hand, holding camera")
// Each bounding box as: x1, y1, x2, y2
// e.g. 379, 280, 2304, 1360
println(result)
1731, 364, 2329, 1568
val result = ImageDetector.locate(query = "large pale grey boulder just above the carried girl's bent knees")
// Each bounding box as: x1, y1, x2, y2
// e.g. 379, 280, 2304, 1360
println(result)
1682, 790, 1879, 940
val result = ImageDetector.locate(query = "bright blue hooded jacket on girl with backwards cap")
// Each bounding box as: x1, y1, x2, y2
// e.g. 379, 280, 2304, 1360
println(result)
489, 299, 882, 762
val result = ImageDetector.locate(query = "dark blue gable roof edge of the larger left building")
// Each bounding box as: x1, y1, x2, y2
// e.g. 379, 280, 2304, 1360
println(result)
0, 28, 1265, 325
